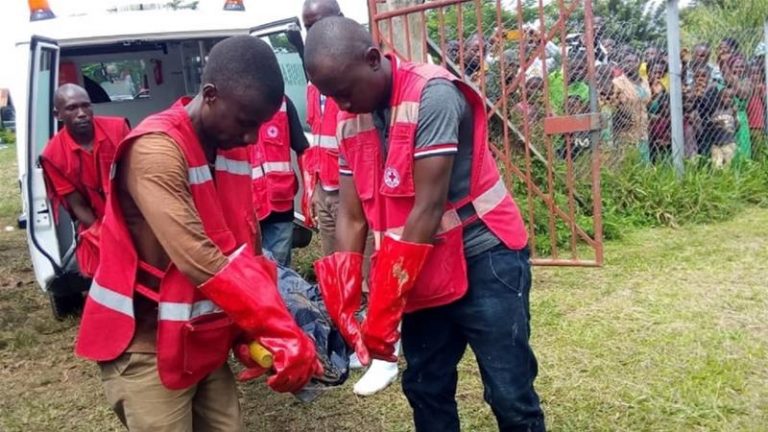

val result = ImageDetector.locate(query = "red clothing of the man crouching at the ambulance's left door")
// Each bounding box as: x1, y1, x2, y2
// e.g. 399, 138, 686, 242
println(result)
40, 116, 129, 277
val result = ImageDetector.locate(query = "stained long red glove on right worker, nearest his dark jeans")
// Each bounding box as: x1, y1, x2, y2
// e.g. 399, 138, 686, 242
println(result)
362, 236, 433, 362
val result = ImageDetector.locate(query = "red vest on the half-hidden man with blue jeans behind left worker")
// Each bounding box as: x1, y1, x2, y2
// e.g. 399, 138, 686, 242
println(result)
249, 99, 298, 220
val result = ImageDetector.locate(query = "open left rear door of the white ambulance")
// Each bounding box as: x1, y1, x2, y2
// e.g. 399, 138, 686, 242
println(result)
21, 36, 88, 318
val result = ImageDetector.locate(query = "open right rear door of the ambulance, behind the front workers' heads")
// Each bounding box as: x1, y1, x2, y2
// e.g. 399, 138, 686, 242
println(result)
250, 17, 312, 247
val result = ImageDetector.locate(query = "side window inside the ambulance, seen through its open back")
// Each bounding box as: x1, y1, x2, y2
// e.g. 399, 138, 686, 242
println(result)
80, 60, 149, 103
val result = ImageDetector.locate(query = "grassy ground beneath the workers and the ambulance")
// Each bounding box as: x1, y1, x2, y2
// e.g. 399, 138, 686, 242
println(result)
0, 143, 768, 432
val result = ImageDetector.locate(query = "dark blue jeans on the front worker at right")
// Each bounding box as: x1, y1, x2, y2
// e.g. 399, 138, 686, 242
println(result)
402, 245, 545, 432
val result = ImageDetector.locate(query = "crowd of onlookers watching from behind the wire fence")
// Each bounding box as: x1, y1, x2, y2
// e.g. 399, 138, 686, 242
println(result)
446, 17, 766, 167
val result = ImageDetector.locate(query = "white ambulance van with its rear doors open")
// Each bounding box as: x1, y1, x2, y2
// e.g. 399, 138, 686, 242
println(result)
11, 0, 366, 318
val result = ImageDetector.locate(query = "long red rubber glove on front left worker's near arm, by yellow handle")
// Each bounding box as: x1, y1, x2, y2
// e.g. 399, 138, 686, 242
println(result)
199, 247, 323, 393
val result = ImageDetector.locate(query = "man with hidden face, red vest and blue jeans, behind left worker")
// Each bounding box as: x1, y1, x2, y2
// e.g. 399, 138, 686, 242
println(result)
246, 96, 309, 267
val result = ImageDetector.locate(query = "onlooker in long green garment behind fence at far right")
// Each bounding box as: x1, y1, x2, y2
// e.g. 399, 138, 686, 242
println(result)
723, 52, 752, 159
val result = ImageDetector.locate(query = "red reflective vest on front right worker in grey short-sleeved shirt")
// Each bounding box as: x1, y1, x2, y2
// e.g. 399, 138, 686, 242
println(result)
339, 56, 528, 312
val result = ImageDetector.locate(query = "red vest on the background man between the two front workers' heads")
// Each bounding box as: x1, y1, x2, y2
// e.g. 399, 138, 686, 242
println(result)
303, 84, 339, 194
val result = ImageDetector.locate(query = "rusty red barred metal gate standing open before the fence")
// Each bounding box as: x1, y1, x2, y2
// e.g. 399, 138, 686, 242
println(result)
369, 0, 607, 266
